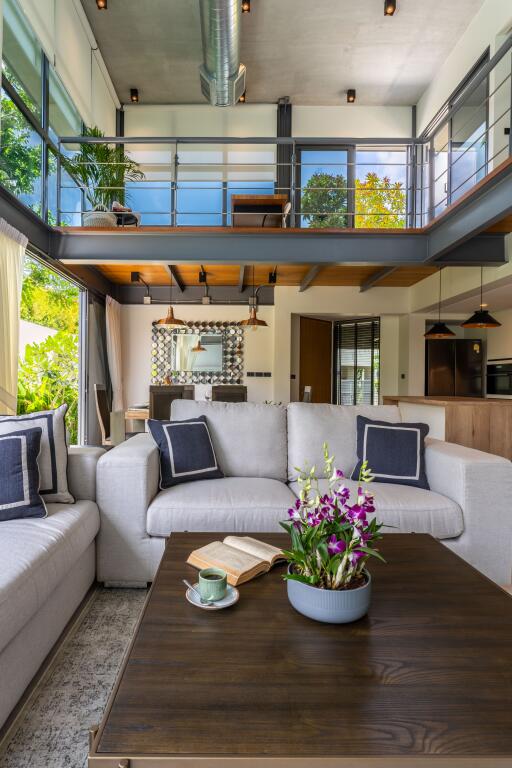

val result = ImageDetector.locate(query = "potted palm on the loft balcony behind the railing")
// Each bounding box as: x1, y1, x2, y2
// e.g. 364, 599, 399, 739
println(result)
61, 126, 144, 227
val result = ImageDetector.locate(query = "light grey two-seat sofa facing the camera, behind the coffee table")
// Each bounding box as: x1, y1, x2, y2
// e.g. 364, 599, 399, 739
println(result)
97, 400, 512, 585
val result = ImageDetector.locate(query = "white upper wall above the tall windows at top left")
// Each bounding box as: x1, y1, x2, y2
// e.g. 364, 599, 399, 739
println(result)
19, 0, 120, 135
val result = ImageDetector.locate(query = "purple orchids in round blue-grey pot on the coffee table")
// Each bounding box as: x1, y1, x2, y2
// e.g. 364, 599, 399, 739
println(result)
281, 444, 384, 624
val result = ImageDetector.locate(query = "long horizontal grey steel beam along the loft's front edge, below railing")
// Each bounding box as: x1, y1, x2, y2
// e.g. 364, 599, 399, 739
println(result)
52, 228, 429, 266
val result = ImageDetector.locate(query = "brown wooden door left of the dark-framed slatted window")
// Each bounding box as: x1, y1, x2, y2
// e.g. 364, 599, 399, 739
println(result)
299, 317, 332, 403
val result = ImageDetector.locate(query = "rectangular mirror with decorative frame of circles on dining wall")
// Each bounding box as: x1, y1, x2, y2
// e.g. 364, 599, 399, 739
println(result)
151, 322, 244, 384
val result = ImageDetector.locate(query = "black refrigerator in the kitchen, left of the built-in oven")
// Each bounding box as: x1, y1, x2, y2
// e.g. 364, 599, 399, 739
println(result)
425, 339, 484, 397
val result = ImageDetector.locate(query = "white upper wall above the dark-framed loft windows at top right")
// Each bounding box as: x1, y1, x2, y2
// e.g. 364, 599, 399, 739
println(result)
416, 0, 512, 134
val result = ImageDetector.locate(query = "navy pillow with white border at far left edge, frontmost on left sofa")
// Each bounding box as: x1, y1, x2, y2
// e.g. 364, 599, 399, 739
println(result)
0, 427, 46, 522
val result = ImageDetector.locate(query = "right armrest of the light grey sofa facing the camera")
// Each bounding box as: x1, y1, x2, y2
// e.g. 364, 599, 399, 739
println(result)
425, 439, 512, 584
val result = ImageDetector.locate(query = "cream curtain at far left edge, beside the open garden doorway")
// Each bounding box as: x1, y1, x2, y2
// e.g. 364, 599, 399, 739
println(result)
0, 219, 28, 415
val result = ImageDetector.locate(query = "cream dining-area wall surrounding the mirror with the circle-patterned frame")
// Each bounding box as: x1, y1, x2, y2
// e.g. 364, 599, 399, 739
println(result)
121, 304, 274, 405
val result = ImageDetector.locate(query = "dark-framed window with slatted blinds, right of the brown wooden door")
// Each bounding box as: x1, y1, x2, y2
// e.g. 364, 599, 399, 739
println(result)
333, 318, 380, 405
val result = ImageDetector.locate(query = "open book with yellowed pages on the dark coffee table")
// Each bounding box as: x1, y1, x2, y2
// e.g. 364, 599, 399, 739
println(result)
187, 536, 286, 586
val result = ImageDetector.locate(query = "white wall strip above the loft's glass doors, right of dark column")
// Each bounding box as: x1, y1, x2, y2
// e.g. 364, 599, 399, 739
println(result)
292, 104, 412, 139
